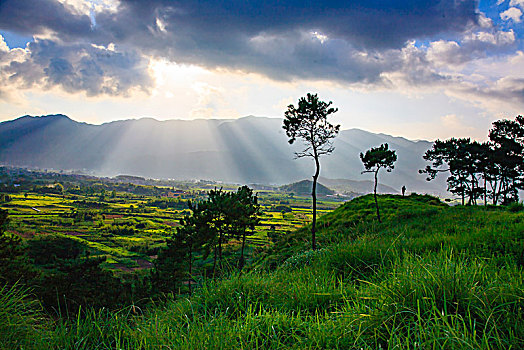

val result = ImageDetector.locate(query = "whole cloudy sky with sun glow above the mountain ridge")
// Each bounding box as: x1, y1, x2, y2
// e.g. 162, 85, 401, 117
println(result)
0, 0, 524, 140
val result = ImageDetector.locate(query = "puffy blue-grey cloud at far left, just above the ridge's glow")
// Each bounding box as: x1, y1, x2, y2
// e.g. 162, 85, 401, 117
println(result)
0, 40, 153, 96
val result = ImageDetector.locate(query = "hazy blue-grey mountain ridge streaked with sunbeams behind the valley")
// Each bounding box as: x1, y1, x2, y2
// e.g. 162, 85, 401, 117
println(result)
0, 114, 445, 194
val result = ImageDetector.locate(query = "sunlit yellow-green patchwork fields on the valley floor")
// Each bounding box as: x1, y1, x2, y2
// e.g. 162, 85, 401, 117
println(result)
0, 187, 339, 272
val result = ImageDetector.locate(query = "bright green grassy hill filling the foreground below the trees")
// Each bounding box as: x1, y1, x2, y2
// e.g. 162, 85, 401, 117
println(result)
4, 195, 524, 349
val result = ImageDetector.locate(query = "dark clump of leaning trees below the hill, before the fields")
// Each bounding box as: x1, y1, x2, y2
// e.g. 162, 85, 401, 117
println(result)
153, 186, 260, 292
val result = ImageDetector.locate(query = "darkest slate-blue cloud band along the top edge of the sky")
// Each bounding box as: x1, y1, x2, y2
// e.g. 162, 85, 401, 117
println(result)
108, 0, 478, 48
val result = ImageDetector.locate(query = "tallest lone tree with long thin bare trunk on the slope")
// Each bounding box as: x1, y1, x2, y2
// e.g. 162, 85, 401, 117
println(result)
283, 93, 340, 250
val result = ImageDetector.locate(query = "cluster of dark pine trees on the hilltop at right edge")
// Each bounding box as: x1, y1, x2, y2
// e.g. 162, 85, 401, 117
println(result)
419, 115, 524, 205
